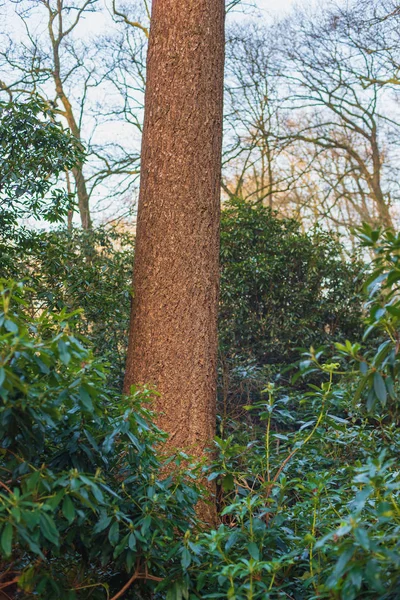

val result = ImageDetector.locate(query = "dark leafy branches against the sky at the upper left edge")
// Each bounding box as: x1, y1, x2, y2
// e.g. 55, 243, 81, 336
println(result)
0, 97, 84, 244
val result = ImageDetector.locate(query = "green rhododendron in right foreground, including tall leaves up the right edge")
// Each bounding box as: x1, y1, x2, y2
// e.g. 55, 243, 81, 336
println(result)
179, 227, 400, 600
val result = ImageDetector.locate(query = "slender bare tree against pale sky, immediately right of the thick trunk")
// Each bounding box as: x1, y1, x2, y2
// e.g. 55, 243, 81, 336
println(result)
222, 26, 283, 205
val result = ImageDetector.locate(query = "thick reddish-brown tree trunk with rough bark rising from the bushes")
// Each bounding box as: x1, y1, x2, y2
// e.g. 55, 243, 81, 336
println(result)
125, 0, 225, 518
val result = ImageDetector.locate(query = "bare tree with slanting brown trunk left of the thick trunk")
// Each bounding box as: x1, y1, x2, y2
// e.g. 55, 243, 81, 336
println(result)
0, 0, 147, 229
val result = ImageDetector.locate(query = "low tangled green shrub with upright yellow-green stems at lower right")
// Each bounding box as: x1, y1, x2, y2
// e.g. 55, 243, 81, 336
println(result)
189, 378, 400, 600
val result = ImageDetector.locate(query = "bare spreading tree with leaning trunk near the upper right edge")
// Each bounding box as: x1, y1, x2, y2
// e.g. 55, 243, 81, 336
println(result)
278, 4, 400, 227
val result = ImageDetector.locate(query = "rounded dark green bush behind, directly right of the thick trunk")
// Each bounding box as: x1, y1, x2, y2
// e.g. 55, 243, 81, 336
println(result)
219, 200, 362, 414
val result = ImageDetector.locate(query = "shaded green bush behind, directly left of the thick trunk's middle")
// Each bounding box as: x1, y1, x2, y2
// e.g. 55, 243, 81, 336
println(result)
4, 227, 134, 390
